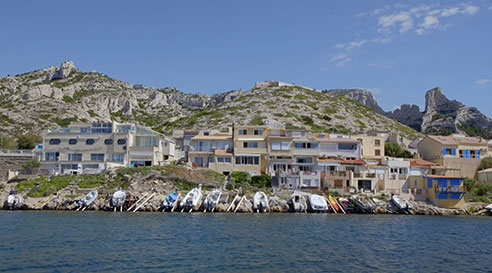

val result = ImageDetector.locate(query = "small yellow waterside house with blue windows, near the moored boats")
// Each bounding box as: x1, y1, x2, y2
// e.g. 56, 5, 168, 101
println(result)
422, 175, 466, 208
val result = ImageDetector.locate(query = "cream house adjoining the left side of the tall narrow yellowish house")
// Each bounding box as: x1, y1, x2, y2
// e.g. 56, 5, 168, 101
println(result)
188, 133, 234, 175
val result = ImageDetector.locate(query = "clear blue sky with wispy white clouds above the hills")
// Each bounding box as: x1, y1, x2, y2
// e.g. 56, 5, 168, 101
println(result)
0, 0, 492, 116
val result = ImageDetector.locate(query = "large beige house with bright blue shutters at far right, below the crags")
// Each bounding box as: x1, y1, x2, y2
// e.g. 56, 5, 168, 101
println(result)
418, 136, 488, 178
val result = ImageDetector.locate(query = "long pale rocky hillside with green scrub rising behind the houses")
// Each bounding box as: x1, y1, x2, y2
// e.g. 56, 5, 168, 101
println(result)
0, 62, 418, 138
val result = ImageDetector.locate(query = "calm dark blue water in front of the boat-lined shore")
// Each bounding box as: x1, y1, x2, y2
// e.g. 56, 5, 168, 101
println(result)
0, 211, 492, 272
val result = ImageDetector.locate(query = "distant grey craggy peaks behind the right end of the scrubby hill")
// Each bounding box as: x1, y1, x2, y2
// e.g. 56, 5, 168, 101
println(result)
324, 87, 492, 136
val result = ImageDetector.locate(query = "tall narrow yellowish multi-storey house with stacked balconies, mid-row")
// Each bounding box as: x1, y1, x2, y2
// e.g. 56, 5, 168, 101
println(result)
233, 125, 268, 175
